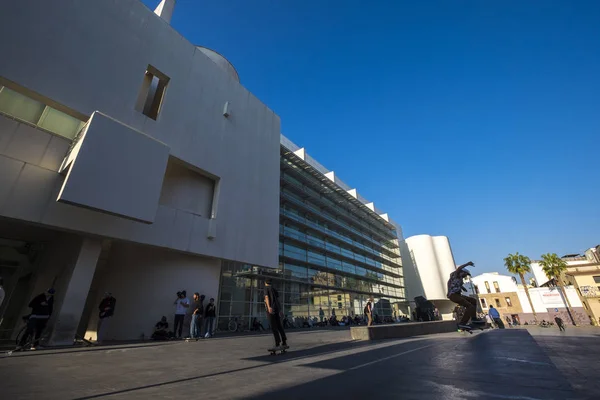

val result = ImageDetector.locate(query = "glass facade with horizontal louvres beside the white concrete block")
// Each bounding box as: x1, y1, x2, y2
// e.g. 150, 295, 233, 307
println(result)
218, 146, 405, 329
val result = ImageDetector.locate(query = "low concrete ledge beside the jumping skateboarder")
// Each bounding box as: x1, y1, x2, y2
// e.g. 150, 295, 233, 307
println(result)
350, 321, 456, 340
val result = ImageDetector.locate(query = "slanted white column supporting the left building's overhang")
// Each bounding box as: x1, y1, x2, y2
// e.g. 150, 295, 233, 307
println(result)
50, 238, 102, 346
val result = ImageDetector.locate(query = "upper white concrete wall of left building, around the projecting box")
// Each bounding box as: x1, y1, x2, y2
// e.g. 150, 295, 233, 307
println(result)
0, 0, 280, 267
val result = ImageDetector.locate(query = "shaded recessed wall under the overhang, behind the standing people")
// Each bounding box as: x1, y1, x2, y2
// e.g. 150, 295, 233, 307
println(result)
85, 243, 221, 340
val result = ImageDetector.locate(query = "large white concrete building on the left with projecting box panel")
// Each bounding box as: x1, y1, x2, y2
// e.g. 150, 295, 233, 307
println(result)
0, 0, 280, 344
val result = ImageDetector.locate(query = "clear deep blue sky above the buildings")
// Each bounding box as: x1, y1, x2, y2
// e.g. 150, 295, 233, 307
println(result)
144, 0, 600, 273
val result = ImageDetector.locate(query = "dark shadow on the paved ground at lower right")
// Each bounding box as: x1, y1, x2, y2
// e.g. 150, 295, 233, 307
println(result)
244, 330, 600, 400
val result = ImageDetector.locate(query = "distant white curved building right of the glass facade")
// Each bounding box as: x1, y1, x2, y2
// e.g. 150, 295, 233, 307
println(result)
400, 235, 456, 319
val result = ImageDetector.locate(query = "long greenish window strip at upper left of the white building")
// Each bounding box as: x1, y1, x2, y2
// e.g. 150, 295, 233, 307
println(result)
0, 86, 84, 139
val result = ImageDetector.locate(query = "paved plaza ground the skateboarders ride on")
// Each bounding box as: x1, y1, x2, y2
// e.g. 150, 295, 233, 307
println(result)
0, 328, 600, 400
